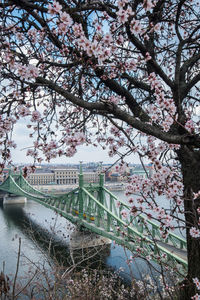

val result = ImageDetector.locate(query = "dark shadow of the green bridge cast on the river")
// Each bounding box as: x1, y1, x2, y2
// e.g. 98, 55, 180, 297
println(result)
0, 202, 113, 270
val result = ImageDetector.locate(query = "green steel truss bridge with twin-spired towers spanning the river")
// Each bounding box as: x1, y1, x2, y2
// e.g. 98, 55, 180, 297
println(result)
0, 168, 187, 275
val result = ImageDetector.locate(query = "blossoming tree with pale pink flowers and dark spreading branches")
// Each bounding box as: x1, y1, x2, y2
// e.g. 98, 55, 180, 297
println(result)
0, 0, 200, 299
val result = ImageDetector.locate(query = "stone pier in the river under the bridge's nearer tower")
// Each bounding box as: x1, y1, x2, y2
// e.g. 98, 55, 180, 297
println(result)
69, 227, 112, 250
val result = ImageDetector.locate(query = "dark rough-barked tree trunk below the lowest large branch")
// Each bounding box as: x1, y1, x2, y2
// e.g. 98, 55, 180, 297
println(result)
177, 146, 200, 300
